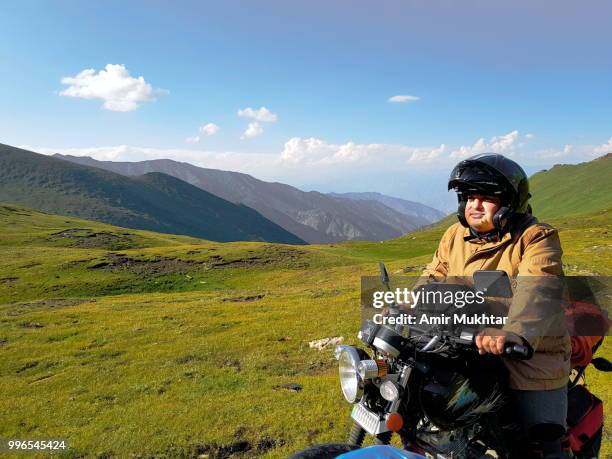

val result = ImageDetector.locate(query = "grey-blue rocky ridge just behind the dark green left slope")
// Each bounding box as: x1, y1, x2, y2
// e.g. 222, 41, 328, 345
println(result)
55, 154, 440, 243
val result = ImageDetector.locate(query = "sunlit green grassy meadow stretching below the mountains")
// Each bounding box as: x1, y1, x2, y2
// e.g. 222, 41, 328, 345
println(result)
0, 205, 612, 458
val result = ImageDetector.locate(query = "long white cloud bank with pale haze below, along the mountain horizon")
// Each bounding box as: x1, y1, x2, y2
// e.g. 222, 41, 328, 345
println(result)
22, 131, 612, 210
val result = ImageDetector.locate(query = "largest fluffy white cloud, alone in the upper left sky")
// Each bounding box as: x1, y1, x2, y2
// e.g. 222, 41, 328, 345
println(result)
59, 64, 168, 112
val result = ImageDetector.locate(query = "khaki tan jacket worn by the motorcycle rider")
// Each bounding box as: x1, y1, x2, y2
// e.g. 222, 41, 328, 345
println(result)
424, 216, 571, 390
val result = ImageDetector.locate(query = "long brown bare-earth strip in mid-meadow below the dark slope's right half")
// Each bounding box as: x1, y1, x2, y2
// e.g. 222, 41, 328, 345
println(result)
89, 253, 203, 275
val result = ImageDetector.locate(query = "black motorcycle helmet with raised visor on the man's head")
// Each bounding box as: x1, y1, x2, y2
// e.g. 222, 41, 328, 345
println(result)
448, 153, 531, 233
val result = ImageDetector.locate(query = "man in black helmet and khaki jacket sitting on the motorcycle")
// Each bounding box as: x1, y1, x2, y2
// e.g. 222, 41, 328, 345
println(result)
424, 153, 571, 458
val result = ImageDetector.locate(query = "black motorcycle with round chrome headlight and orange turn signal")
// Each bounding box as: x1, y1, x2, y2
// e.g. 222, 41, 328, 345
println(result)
292, 263, 612, 459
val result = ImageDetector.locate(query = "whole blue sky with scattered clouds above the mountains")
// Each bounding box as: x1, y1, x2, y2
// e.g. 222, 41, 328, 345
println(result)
0, 0, 612, 207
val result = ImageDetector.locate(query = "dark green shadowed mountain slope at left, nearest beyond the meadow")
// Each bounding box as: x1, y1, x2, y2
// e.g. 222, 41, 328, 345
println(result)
0, 144, 304, 244
